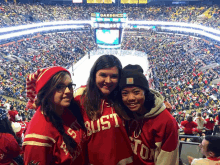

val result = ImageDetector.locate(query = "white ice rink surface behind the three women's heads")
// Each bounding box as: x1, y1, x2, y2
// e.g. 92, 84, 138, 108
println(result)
68, 50, 149, 89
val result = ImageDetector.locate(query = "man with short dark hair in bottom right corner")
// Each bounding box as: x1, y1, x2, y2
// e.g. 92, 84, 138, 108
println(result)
188, 135, 220, 165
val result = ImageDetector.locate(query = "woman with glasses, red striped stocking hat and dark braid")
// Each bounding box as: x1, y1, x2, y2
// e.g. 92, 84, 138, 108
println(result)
22, 66, 88, 165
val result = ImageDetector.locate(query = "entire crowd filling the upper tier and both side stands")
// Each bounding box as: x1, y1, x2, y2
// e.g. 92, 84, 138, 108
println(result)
0, 3, 220, 138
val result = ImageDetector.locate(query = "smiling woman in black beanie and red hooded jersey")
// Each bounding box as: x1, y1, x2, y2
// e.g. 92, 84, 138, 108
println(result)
118, 65, 179, 165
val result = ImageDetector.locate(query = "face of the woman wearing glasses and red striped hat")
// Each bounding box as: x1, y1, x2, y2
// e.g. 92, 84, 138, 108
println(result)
52, 74, 73, 111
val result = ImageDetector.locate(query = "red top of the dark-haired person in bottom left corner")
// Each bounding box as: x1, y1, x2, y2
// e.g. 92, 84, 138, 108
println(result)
0, 133, 21, 165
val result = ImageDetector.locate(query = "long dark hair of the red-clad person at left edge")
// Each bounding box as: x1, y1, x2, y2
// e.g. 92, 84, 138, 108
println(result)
0, 118, 21, 144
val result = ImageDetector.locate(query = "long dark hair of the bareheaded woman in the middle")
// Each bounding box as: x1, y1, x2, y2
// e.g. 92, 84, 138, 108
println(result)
81, 55, 122, 120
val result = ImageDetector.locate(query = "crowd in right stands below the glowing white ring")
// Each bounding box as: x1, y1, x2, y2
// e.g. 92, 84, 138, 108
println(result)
122, 30, 220, 128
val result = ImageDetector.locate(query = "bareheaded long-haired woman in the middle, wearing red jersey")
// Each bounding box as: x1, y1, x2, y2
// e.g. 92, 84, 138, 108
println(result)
75, 55, 133, 165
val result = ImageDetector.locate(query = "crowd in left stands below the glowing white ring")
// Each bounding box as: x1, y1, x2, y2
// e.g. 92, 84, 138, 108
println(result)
0, 31, 95, 104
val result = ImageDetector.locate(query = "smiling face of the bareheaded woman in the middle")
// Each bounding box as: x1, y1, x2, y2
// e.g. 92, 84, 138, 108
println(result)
96, 67, 118, 96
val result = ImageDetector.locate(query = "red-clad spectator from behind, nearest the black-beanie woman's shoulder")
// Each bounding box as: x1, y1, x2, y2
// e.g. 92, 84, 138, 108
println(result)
181, 116, 198, 135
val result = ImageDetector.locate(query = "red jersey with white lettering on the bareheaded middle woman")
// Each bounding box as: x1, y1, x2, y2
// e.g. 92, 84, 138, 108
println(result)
75, 95, 133, 165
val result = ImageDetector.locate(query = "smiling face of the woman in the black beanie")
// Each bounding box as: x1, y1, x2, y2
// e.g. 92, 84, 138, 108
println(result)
121, 87, 145, 114
